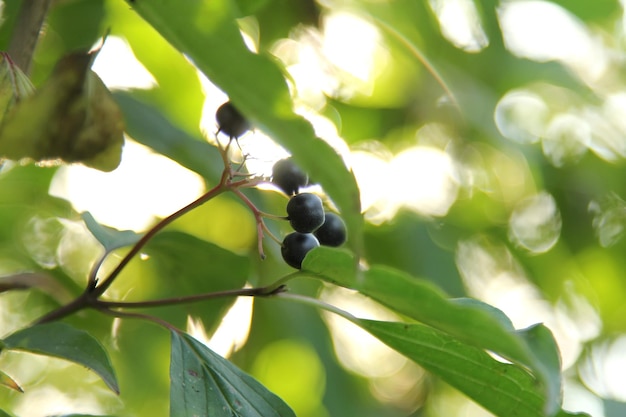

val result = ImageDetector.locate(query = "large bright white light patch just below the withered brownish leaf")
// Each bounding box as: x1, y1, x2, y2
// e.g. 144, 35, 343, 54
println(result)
50, 140, 204, 231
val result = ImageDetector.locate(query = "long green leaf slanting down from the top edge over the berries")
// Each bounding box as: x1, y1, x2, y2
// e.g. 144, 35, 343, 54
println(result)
125, 0, 363, 254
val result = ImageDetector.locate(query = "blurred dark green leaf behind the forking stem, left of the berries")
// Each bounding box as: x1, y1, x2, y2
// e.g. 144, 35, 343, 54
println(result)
140, 231, 250, 331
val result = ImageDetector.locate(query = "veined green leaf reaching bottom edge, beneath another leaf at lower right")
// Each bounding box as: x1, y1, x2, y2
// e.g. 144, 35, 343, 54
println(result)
353, 319, 584, 417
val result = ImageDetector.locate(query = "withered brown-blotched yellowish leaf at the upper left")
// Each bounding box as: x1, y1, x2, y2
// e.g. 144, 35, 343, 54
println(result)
0, 52, 124, 171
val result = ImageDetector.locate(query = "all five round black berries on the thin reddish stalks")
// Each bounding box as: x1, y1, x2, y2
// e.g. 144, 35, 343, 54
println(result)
215, 102, 347, 269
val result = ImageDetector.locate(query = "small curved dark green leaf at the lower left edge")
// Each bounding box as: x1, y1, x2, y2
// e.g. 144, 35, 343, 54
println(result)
2, 323, 120, 394
